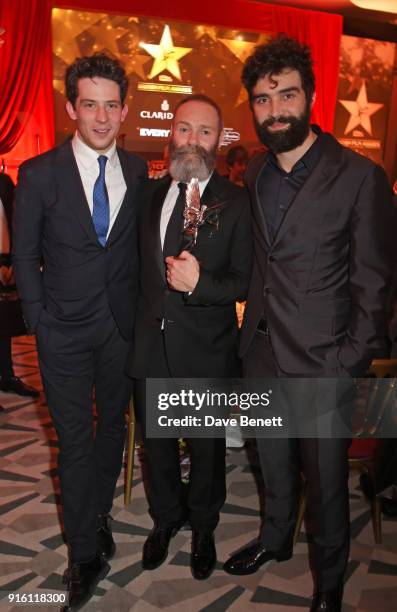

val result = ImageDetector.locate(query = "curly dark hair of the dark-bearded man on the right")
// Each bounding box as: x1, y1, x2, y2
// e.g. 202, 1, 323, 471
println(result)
241, 34, 315, 100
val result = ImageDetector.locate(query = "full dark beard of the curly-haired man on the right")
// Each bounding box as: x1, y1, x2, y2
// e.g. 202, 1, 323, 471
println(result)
254, 104, 311, 154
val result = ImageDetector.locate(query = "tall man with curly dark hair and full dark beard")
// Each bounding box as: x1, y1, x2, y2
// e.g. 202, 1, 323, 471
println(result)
224, 36, 393, 612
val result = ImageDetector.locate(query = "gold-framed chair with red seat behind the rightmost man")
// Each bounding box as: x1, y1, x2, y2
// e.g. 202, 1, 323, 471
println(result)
294, 359, 397, 545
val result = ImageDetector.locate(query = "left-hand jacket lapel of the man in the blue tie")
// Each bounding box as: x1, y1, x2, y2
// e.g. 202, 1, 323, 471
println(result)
55, 140, 98, 242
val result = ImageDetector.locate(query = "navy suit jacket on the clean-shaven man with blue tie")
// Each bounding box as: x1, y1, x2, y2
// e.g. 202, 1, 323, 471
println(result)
13, 141, 146, 339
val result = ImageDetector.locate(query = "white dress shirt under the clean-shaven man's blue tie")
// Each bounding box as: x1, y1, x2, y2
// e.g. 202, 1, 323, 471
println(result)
72, 132, 127, 236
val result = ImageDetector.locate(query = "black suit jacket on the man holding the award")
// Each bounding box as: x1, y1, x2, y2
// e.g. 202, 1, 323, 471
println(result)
129, 172, 252, 378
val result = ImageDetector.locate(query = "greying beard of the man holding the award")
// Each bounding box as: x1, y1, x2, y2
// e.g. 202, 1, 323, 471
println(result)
169, 140, 218, 183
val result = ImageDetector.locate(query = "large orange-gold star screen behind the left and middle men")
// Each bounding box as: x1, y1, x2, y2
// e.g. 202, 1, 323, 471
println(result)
52, 9, 268, 155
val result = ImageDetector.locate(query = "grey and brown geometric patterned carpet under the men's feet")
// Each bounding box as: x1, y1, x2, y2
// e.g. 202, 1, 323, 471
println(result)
0, 337, 397, 612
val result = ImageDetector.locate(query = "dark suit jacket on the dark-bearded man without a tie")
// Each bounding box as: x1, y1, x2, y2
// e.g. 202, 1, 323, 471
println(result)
240, 134, 395, 376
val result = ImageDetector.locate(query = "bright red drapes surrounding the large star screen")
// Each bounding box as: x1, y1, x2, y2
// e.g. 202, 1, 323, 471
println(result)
0, 0, 342, 179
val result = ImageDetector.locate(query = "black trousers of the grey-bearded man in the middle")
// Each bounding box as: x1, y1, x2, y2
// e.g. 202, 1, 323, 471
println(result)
135, 331, 226, 530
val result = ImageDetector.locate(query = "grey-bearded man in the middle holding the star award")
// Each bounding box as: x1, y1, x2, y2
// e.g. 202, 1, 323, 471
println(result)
128, 95, 252, 579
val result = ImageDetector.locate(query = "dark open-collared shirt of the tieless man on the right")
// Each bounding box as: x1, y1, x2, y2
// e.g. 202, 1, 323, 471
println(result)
258, 125, 324, 242
